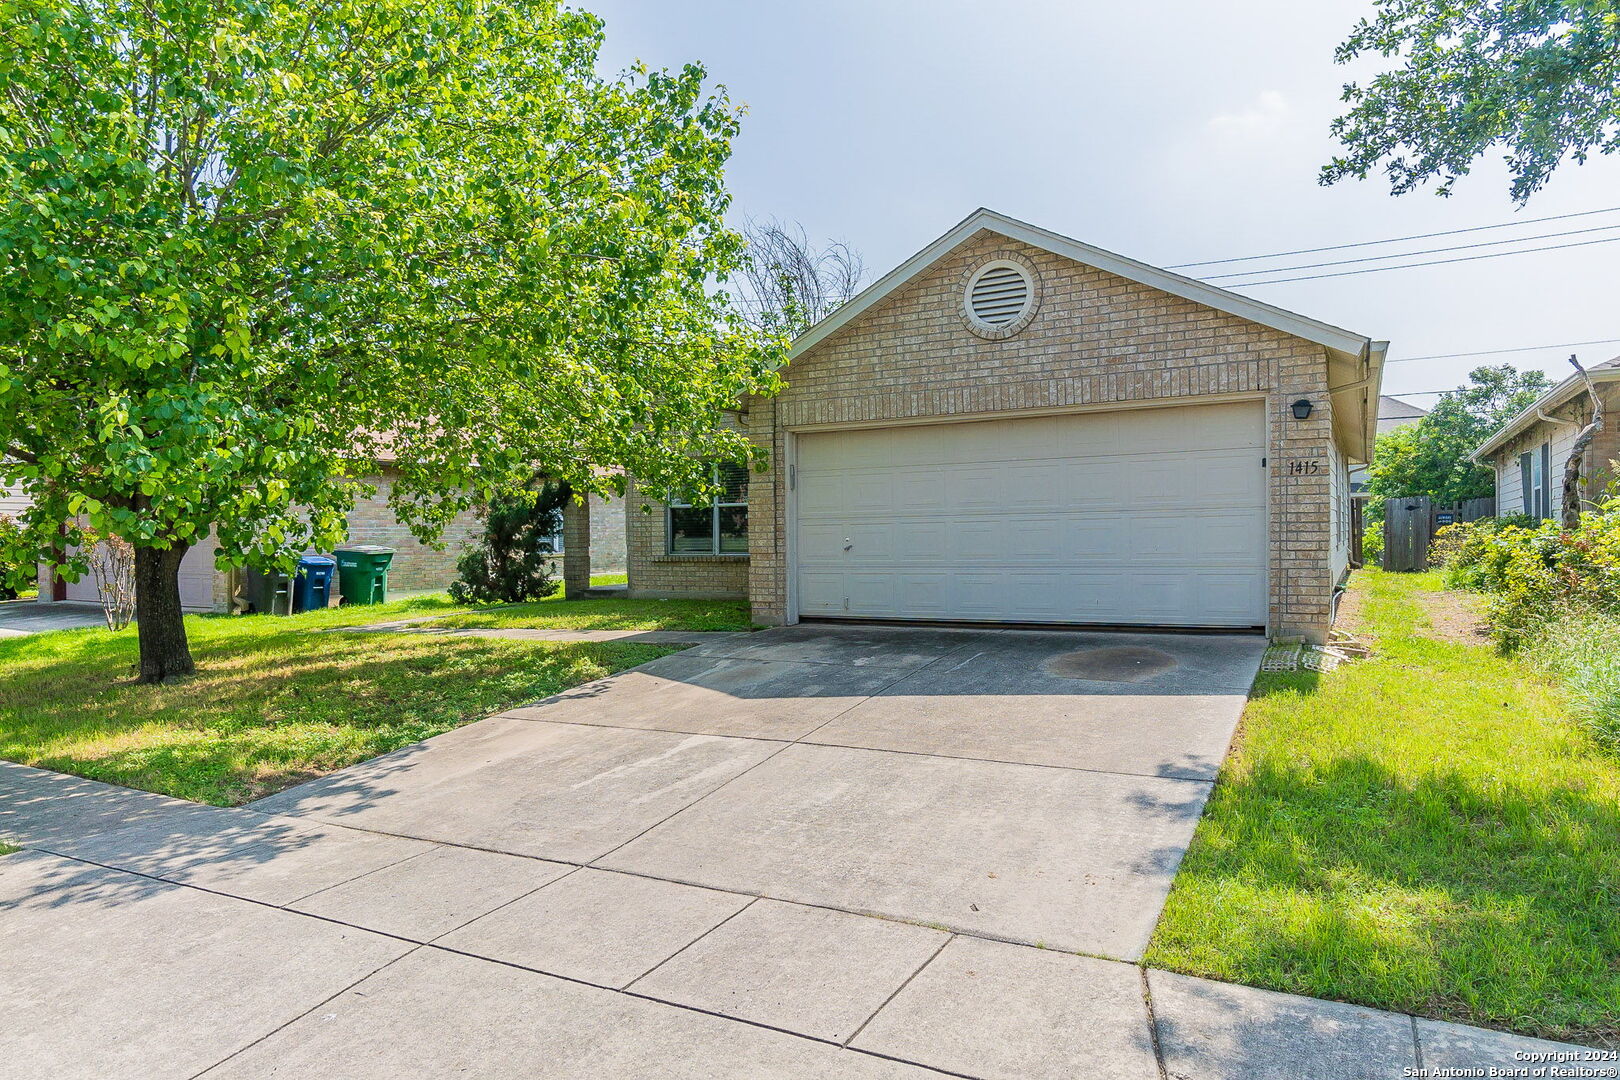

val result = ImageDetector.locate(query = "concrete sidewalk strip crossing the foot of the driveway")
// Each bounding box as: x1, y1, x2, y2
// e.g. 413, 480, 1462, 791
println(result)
0, 808, 1607, 1080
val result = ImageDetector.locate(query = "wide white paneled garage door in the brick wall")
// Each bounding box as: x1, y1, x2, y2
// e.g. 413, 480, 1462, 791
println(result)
795, 403, 1267, 627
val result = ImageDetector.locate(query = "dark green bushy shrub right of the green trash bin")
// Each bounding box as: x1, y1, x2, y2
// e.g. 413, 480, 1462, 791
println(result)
450, 483, 570, 604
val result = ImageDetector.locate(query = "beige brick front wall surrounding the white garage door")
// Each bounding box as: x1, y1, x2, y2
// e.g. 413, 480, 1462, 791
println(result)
630, 225, 1335, 638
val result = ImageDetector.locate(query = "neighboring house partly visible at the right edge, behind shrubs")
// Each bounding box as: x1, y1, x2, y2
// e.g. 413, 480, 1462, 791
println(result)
1471, 358, 1620, 518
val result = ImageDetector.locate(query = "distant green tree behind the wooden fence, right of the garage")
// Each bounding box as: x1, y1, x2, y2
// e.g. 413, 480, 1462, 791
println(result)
1367, 364, 1552, 502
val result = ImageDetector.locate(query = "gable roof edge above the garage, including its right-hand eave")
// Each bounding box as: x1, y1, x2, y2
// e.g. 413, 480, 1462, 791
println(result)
787, 207, 1388, 458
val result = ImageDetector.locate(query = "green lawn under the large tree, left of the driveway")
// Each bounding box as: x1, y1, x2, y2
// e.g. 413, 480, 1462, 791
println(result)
0, 596, 671, 806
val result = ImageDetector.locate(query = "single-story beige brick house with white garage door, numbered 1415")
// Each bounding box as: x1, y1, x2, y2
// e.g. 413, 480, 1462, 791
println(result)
565, 210, 1387, 640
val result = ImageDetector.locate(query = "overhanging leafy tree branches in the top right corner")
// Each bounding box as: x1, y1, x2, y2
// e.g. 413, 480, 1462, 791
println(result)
1322, 0, 1620, 202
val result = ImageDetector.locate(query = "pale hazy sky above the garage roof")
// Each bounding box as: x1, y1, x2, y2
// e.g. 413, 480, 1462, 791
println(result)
585, 0, 1620, 405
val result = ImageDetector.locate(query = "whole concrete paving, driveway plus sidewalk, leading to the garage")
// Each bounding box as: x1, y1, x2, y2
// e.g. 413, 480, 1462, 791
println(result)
0, 627, 1587, 1080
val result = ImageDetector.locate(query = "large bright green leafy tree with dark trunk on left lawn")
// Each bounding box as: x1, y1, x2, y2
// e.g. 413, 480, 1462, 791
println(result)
0, 0, 781, 682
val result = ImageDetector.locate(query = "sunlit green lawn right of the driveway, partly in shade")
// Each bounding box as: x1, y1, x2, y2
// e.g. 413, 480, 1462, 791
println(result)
1145, 570, 1620, 1044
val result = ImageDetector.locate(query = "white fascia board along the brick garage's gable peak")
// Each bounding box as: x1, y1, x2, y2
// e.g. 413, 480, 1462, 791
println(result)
787, 207, 1369, 359
